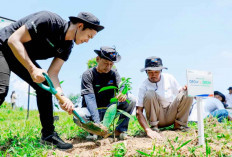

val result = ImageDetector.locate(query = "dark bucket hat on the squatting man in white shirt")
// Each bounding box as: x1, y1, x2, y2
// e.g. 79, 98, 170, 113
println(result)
141, 56, 168, 72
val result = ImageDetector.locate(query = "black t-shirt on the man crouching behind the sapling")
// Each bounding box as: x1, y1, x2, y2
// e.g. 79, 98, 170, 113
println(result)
81, 67, 121, 107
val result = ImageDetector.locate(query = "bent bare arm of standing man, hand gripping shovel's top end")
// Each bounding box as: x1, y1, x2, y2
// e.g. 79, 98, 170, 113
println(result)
8, 25, 46, 83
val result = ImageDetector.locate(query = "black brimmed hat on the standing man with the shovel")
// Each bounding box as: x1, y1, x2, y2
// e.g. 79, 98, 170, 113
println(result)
69, 12, 104, 32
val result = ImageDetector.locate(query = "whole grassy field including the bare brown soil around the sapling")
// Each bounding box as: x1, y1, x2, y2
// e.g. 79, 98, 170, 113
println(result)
0, 104, 232, 157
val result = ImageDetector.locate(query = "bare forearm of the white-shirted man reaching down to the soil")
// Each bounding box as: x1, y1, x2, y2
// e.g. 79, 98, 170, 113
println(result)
136, 106, 161, 139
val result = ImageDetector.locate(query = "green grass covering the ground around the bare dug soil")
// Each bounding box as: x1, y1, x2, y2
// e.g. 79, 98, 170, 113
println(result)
0, 104, 232, 157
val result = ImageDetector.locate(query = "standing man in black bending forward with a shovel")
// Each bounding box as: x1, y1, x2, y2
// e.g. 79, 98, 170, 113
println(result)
0, 11, 104, 149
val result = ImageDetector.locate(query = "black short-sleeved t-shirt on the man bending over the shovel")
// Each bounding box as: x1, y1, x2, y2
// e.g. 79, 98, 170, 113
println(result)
0, 11, 73, 61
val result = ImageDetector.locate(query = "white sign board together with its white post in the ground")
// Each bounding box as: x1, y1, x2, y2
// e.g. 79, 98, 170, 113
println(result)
187, 70, 213, 145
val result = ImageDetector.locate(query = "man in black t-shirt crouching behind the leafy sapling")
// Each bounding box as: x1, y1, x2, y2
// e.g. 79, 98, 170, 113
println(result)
74, 46, 135, 139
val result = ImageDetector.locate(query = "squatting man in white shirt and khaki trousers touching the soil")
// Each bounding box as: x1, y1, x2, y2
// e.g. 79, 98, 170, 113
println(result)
136, 56, 192, 139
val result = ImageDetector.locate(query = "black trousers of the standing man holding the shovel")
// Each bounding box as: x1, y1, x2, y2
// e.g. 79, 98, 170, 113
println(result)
0, 50, 55, 137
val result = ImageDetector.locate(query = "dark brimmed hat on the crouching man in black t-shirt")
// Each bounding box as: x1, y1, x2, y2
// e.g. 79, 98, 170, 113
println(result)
94, 46, 121, 63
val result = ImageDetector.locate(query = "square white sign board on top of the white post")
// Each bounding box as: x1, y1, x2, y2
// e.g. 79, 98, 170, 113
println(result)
187, 70, 213, 97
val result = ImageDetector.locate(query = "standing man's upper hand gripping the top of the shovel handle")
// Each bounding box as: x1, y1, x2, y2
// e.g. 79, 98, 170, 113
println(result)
30, 67, 48, 83
